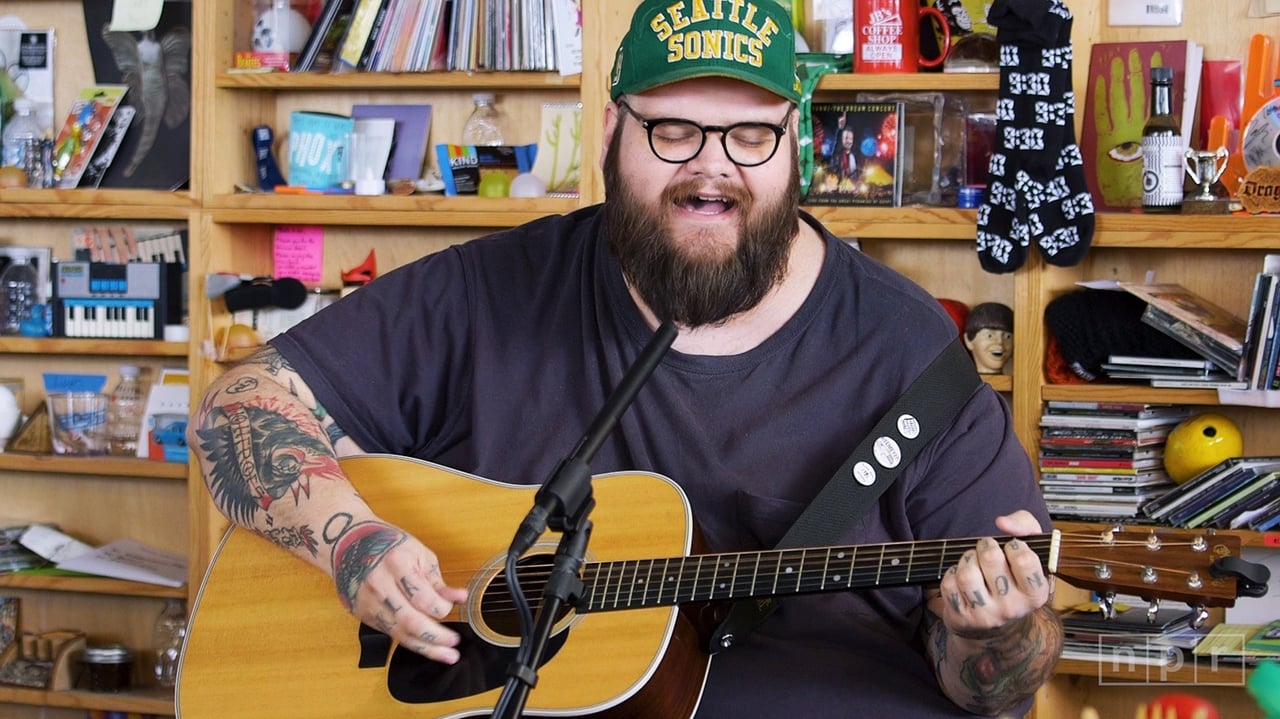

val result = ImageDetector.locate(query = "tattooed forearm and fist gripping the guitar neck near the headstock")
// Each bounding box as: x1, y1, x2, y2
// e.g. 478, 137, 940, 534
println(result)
924, 512, 1062, 715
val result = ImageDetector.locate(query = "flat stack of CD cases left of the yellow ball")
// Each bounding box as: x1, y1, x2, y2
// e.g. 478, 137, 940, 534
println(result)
1039, 400, 1192, 521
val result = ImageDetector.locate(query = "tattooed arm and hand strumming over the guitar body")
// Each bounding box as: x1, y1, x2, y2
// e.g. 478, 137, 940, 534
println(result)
187, 347, 466, 664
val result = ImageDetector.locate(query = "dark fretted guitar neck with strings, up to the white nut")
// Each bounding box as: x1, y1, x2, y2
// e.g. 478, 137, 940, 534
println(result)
577, 531, 1060, 613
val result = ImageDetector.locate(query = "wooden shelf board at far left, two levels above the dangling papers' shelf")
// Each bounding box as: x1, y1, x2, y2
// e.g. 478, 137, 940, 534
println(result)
0, 188, 196, 221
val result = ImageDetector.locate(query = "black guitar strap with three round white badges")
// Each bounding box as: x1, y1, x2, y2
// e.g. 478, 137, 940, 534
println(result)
709, 339, 982, 654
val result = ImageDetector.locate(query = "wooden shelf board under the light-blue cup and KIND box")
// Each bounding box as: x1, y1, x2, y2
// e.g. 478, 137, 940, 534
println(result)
206, 193, 579, 228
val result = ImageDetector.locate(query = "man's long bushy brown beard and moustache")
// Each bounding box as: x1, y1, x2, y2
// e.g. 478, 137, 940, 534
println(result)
604, 132, 800, 328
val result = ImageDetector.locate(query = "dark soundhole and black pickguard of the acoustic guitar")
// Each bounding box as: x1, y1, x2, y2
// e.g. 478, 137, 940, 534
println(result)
387, 554, 570, 704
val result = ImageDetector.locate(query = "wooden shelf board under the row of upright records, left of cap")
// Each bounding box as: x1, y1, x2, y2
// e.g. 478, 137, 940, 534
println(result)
214, 70, 581, 92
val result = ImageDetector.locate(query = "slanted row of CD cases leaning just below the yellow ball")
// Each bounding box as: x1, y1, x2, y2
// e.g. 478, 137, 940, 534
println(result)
1142, 457, 1280, 532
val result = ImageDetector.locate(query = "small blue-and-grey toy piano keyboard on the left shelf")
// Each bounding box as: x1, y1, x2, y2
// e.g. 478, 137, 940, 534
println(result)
52, 261, 182, 339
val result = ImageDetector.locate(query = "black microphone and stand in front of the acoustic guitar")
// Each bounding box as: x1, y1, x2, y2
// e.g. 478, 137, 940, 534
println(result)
493, 321, 677, 719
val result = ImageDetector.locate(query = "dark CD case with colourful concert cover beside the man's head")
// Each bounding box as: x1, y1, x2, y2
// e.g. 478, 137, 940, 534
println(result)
805, 102, 902, 207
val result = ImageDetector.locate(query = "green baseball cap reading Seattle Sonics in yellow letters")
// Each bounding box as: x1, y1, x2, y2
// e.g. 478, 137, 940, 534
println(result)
609, 0, 800, 102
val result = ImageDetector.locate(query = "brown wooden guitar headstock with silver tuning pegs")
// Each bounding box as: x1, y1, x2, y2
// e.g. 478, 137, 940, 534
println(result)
1055, 527, 1270, 606
